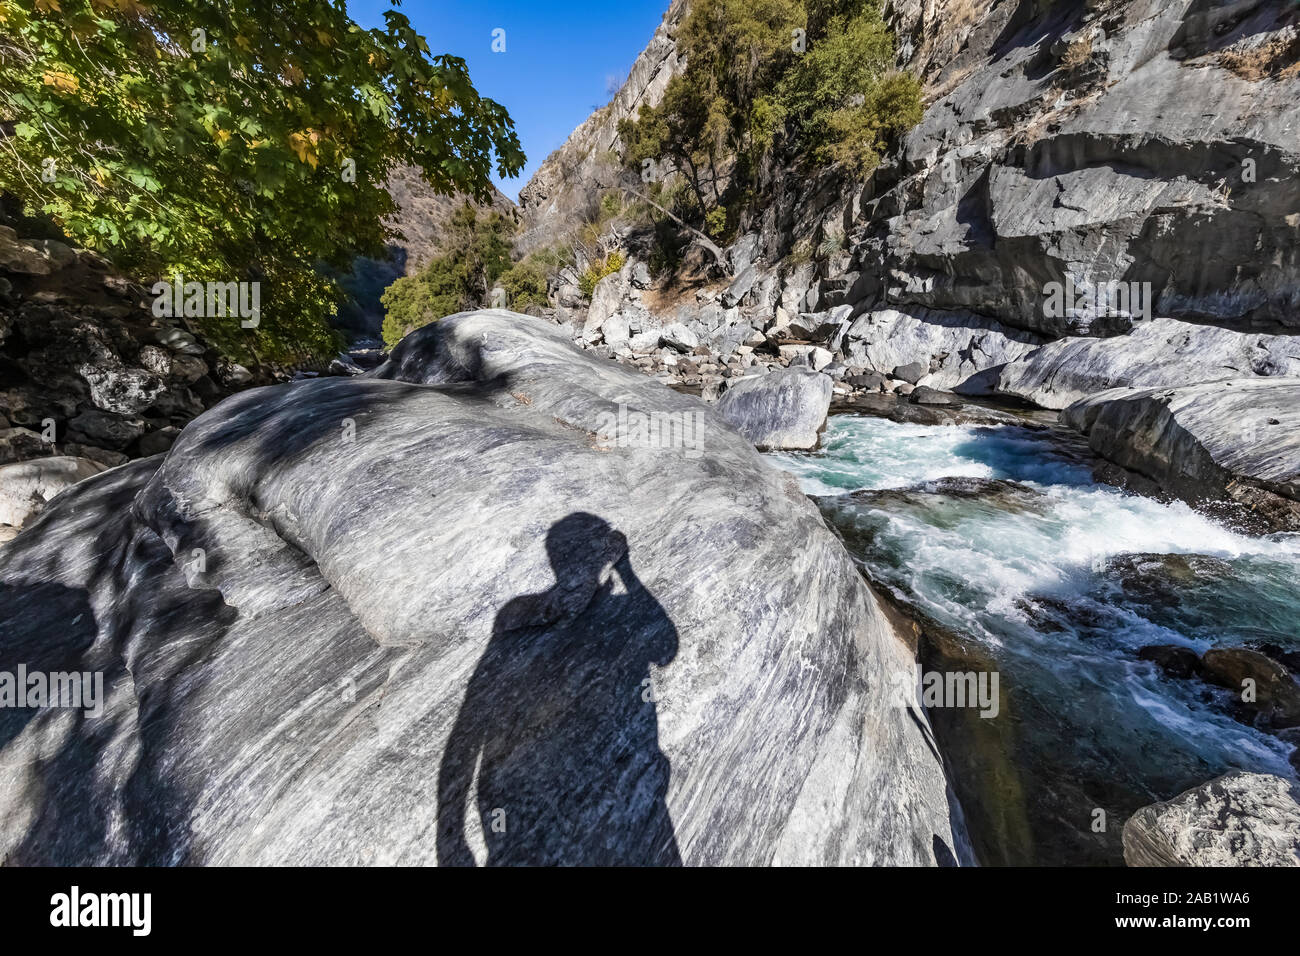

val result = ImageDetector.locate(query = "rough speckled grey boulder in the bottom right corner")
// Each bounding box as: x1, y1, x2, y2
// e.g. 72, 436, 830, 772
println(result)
1125, 771, 1300, 866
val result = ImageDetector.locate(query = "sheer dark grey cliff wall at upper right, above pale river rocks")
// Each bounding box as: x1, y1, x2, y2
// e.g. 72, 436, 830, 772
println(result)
854, 0, 1300, 338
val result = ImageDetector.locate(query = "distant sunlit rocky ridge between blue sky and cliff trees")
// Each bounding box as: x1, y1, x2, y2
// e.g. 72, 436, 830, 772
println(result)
516, 0, 688, 252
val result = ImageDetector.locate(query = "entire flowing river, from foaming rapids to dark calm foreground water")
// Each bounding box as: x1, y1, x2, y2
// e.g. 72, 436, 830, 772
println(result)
771, 415, 1300, 864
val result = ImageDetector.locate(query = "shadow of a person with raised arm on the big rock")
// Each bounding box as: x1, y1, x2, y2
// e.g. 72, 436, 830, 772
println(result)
438, 512, 681, 866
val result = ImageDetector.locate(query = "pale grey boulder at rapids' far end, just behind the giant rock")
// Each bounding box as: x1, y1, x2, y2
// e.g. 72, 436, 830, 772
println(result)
718, 369, 835, 451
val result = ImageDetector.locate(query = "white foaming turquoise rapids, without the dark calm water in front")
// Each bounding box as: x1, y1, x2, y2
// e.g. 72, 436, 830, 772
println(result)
770, 416, 1300, 775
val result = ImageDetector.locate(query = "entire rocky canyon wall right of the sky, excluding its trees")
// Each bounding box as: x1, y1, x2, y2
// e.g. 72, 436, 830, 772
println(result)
523, 0, 1300, 408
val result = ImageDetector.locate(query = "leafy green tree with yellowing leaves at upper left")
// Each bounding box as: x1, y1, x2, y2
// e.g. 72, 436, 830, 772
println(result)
0, 0, 524, 360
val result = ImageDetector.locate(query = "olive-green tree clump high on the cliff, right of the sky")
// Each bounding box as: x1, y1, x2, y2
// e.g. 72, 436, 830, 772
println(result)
619, 0, 922, 237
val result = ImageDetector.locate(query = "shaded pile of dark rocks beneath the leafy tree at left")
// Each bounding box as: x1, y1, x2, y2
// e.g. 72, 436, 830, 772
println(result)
0, 225, 269, 541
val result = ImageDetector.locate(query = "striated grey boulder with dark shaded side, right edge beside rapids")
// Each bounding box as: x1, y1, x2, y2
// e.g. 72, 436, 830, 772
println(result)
1063, 378, 1300, 531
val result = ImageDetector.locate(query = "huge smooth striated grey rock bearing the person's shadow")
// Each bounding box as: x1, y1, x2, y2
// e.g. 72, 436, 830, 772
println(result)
0, 312, 970, 864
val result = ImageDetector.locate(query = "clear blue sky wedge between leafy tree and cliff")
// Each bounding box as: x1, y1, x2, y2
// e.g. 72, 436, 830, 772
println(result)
347, 0, 668, 199
